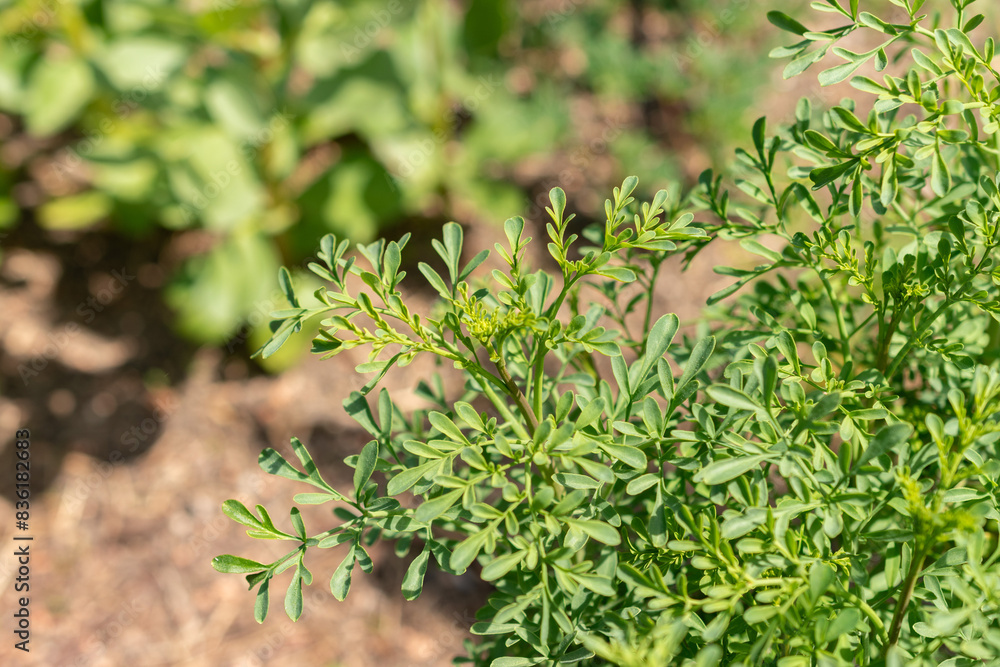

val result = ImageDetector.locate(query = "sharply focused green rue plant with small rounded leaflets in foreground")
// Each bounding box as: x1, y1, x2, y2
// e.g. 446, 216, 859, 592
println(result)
216, 0, 1000, 667
